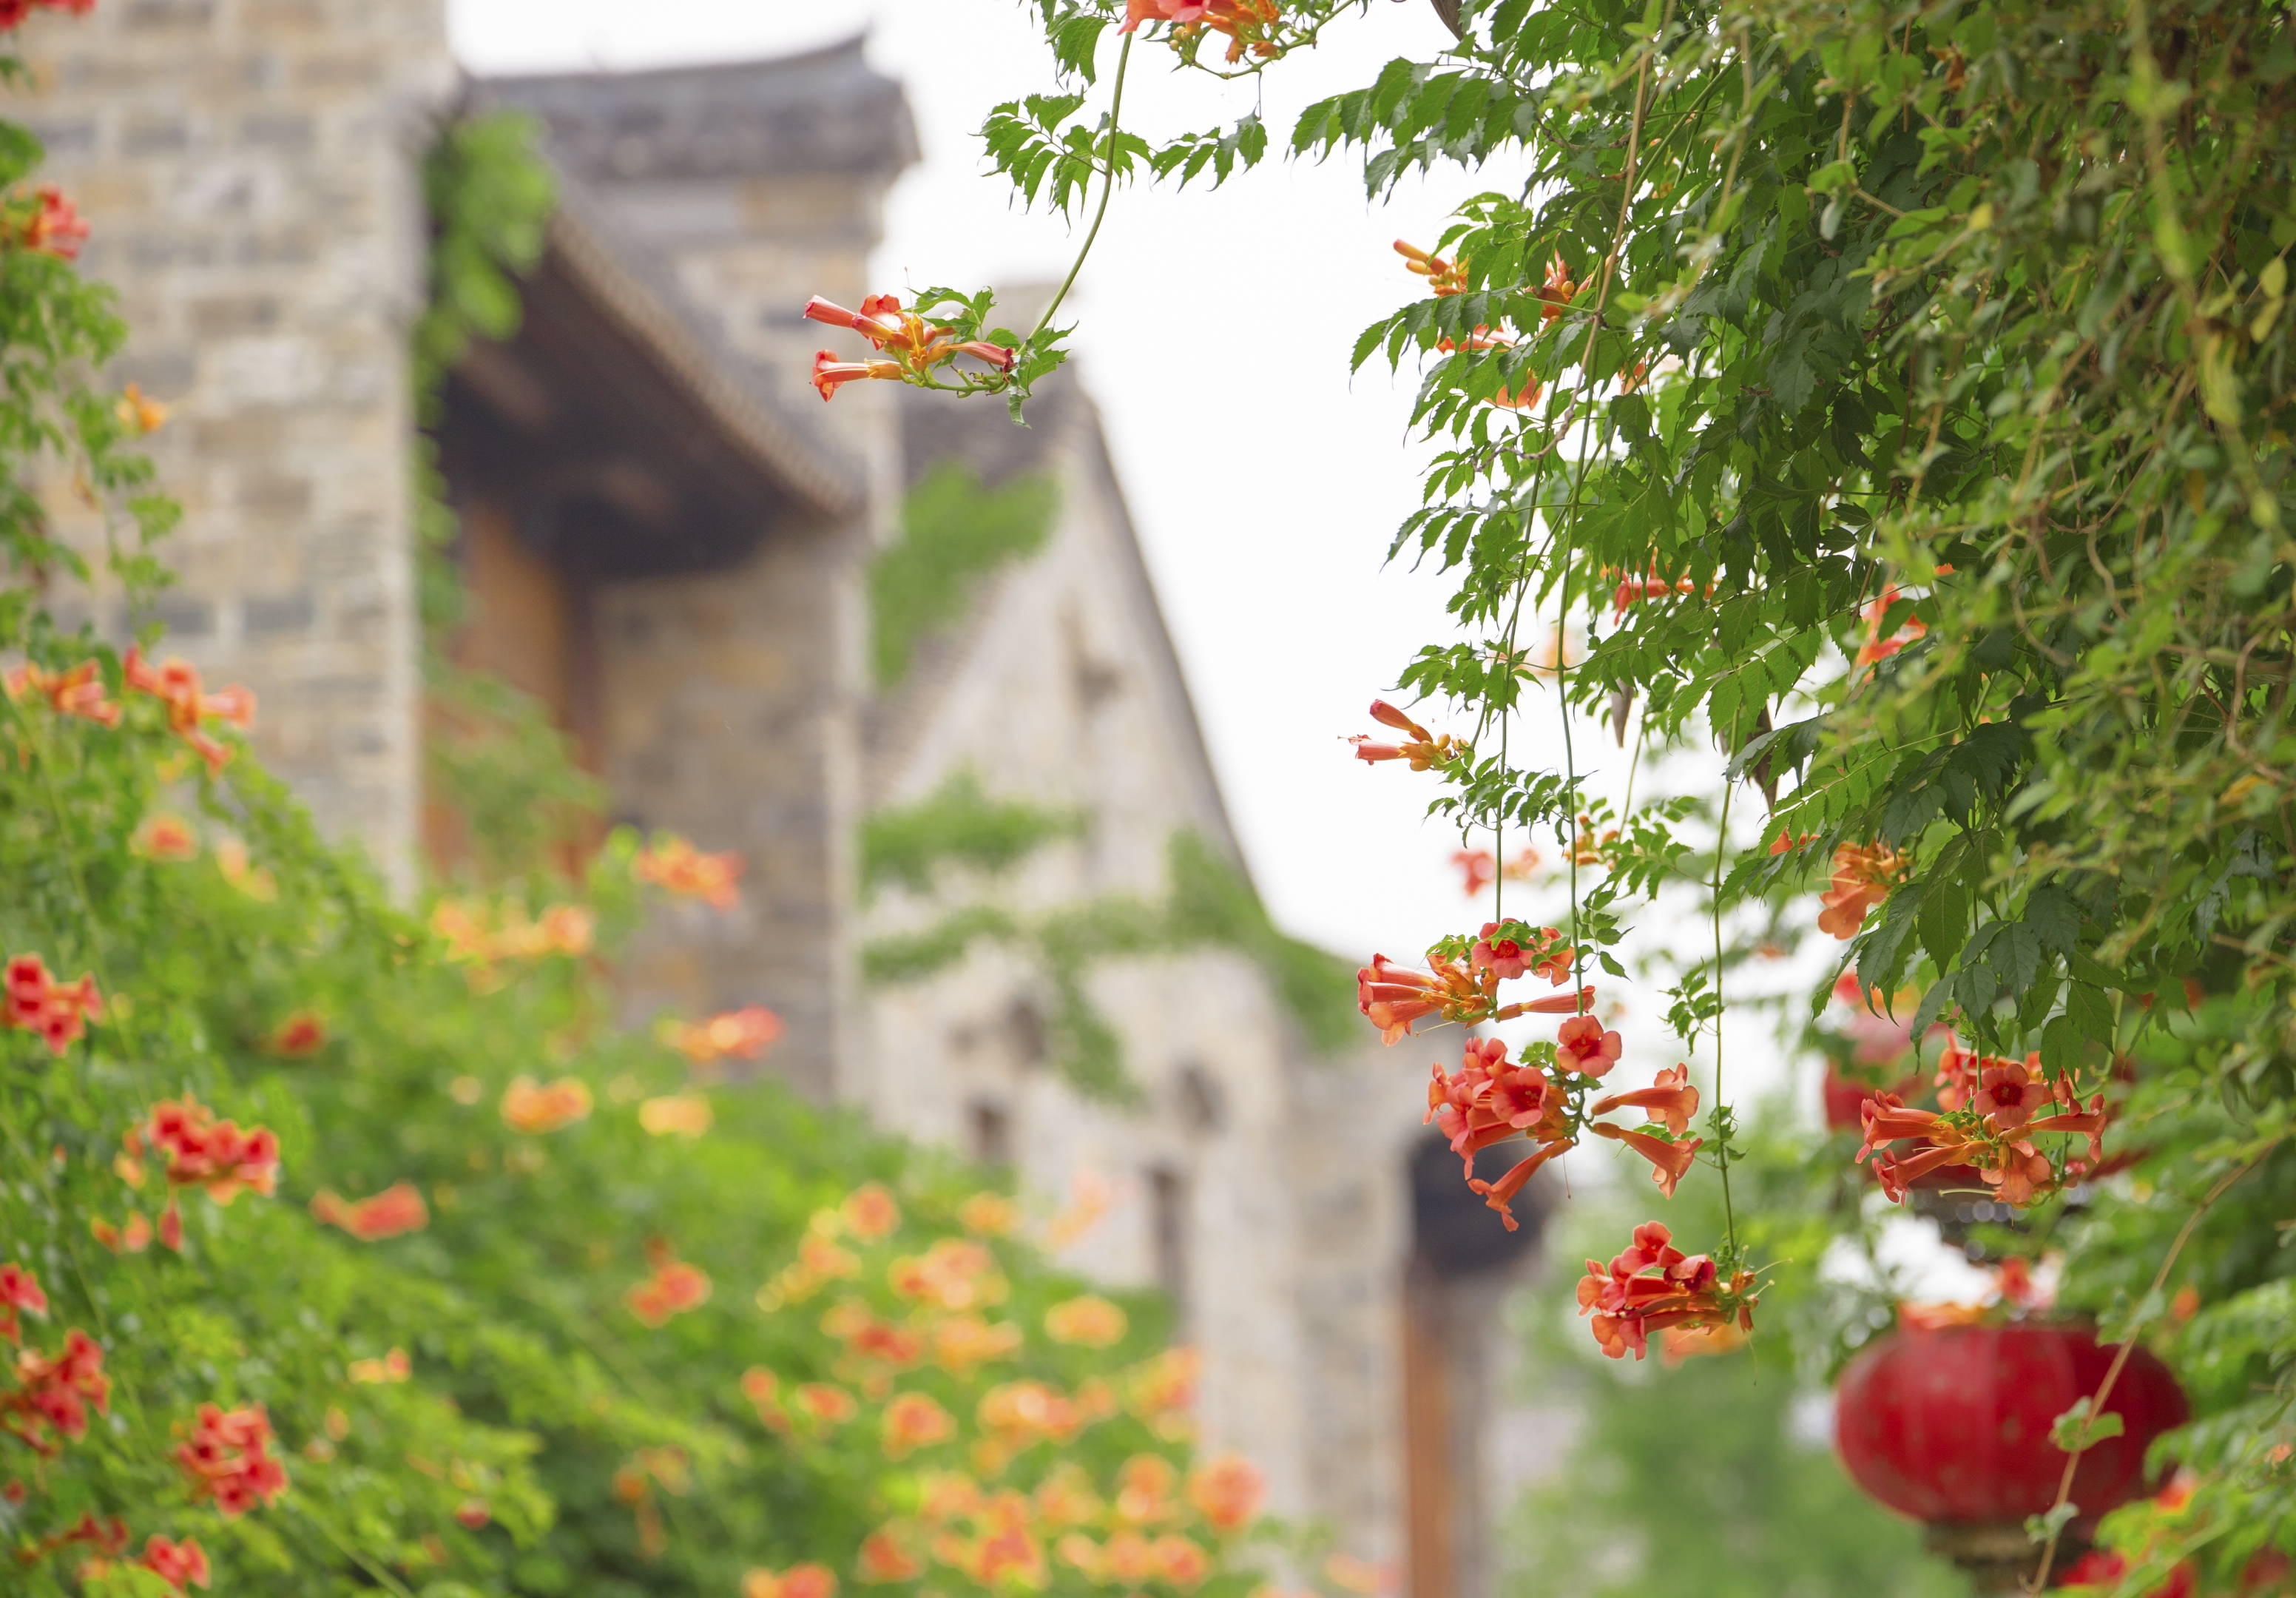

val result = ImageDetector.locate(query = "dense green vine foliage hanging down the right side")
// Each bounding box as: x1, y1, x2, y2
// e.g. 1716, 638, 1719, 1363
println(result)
1003, 0, 2296, 1594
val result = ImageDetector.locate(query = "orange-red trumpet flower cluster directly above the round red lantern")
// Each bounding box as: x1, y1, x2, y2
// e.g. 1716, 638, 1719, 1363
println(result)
1857, 1045, 2110, 1207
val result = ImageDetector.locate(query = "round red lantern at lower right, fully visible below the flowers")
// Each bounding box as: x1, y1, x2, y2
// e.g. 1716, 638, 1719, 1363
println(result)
1834, 1323, 2190, 1591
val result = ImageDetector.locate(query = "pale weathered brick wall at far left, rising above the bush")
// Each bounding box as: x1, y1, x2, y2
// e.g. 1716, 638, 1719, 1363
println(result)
25, 0, 455, 884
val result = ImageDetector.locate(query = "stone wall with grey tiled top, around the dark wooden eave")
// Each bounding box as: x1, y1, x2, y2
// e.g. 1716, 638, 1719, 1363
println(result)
478, 48, 914, 1097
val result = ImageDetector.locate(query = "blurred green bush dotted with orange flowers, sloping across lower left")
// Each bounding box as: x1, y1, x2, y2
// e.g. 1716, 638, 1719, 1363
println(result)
0, 47, 1252, 1598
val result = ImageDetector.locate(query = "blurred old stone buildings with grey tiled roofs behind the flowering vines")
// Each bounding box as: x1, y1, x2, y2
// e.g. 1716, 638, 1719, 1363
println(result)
13, 16, 1561, 1598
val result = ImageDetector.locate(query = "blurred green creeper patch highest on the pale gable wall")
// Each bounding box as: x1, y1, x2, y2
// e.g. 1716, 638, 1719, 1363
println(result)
868, 462, 1061, 689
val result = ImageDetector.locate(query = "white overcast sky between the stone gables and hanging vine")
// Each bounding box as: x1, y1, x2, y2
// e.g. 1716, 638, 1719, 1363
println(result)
452, 0, 1510, 960
